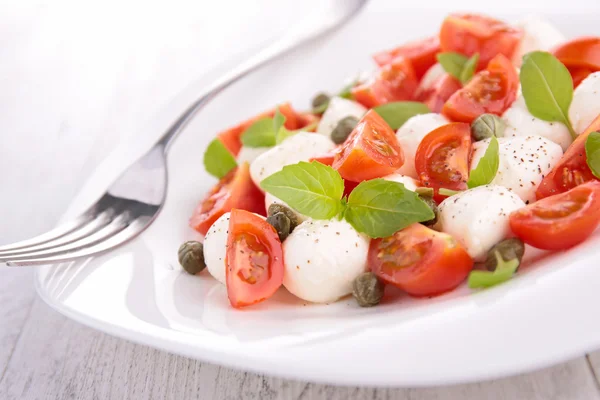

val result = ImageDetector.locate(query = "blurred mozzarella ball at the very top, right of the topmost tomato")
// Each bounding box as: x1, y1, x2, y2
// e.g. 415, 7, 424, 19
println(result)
513, 17, 567, 66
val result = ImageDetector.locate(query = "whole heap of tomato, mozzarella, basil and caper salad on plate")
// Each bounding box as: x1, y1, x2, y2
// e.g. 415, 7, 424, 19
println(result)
179, 14, 600, 308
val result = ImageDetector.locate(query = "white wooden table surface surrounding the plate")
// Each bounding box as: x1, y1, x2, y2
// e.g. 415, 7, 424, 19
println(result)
0, 0, 600, 400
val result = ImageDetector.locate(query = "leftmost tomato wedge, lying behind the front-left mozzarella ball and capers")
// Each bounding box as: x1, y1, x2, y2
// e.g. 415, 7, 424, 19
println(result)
190, 163, 266, 235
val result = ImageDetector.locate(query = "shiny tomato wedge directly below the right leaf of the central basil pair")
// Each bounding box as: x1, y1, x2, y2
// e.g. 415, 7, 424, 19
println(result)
368, 224, 473, 296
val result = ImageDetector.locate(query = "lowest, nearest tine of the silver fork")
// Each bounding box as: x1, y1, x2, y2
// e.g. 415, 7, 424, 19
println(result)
0, 217, 151, 267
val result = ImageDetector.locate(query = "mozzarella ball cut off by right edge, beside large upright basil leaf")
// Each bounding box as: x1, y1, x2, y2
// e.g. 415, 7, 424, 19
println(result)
569, 71, 600, 135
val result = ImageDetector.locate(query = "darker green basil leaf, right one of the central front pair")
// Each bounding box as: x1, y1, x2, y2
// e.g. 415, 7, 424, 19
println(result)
344, 179, 435, 238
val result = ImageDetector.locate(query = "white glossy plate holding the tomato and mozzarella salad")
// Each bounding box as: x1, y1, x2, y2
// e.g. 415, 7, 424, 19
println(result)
36, 2, 600, 386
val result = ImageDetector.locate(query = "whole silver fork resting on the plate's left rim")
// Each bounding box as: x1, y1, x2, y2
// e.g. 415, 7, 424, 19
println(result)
0, 0, 368, 266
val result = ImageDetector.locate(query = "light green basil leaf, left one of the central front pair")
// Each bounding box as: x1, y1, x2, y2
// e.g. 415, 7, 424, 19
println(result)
260, 161, 344, 219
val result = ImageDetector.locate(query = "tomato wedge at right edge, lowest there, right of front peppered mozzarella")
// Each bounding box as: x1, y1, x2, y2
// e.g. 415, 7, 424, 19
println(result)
510, 181, 600, 250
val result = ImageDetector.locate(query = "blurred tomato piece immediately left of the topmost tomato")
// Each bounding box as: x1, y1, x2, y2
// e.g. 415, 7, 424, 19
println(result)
373, 36, 440, 79
